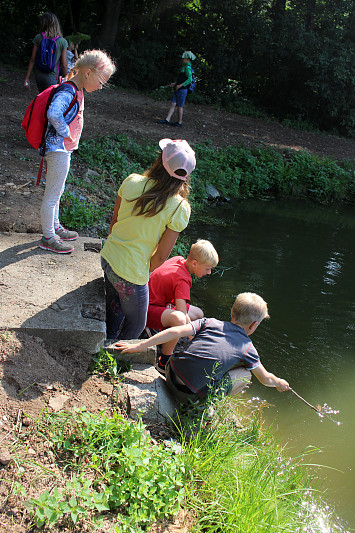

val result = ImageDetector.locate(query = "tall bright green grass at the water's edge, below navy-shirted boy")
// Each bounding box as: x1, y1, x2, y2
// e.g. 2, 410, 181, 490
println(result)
177, 398, 336, 533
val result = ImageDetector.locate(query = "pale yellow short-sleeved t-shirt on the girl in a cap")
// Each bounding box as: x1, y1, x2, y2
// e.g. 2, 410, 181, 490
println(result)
101, 174, 191, 285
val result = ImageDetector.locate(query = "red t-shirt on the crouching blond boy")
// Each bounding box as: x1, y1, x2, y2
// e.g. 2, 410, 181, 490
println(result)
149, 255, 192, 307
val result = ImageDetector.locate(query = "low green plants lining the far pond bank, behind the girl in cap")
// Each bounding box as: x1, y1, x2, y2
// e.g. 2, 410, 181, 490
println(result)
67, 135, 355, 236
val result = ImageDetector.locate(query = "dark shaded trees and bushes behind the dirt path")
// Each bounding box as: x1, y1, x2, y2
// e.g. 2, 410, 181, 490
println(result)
0, 0, 355, 136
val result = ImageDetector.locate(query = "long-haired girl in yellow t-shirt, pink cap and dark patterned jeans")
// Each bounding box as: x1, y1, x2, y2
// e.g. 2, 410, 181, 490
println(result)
101, 139, 196, 343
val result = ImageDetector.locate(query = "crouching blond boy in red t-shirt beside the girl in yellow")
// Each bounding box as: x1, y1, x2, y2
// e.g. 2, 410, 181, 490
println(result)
147, 239, 219, 373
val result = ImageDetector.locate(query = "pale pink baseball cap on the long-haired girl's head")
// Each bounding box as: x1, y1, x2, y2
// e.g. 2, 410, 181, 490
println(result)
159, 139, 196, 181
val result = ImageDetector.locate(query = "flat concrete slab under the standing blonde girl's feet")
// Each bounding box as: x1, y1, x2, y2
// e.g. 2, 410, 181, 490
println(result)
0, 233, 105, 353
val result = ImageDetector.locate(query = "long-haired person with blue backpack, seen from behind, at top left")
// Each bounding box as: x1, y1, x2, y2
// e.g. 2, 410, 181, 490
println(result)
24, 12, 68, 92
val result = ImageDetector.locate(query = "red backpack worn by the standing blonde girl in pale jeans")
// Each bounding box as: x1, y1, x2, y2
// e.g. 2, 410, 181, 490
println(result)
22, 81, 78, 185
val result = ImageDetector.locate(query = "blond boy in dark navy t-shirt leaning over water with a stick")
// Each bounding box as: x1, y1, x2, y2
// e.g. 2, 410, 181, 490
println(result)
115, 292, 289, 403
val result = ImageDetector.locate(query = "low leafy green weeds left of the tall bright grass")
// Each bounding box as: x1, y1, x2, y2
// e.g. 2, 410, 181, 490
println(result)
28, 409, 184, 533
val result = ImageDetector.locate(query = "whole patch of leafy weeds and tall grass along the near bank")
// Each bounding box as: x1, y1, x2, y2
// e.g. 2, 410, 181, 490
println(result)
2, 388, 342, 533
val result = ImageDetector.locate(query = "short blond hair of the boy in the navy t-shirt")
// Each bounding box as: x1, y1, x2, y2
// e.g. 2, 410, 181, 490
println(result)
232, 292, 270, 326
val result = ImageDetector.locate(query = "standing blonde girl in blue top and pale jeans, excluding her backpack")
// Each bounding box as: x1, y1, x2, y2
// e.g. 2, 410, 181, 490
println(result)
39, 50, 116, 253
